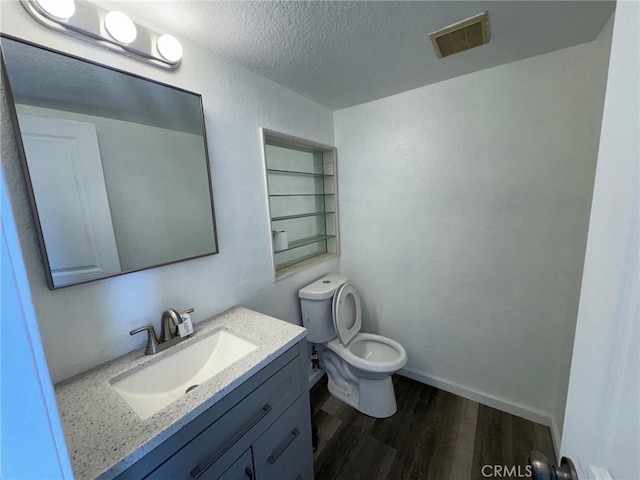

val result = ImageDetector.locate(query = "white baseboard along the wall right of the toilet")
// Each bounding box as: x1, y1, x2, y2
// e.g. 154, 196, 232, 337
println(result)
398, 368, 559, 428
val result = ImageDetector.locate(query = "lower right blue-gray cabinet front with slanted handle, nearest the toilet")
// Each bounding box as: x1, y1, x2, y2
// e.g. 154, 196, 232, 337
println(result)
253, 396, 313, 480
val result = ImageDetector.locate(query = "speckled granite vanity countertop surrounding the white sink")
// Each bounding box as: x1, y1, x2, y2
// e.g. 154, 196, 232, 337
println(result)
55, 307, 305, 479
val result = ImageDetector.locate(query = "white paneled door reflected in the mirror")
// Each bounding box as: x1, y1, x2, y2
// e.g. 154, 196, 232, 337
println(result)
19, 115, 121, 286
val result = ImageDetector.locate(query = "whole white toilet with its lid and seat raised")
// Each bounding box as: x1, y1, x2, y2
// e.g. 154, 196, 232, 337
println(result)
298, 274, 407, 418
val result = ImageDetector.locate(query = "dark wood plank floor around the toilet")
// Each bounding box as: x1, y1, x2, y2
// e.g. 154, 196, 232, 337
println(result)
311, 375, 555, 480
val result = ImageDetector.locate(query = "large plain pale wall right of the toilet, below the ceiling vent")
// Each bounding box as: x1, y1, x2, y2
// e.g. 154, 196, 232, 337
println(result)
334, 15, 611, 442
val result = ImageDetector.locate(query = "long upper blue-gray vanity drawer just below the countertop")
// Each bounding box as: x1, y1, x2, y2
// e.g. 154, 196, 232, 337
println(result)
146, 360, 302, 480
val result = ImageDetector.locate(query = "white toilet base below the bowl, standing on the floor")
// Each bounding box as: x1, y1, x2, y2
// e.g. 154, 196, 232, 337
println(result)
327, 372, 398, 418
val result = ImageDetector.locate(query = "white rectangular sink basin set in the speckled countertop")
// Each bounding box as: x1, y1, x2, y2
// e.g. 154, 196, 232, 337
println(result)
111, 329, 258, 419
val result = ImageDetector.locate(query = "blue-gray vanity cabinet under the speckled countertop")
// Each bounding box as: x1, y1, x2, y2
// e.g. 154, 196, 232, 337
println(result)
116, 340, 313, 480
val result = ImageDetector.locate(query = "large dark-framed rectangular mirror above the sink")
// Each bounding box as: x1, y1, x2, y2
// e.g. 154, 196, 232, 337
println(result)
1, 35, 218, 289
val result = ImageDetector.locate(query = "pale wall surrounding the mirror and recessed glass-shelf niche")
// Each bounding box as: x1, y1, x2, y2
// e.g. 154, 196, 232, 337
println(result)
1, 2, 339, 382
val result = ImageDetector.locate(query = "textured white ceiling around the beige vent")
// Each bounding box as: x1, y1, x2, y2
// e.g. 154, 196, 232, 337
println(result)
100, 0, 615, 110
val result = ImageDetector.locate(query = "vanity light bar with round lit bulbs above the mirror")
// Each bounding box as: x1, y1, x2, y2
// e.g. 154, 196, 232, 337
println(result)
19, 0, 182, 70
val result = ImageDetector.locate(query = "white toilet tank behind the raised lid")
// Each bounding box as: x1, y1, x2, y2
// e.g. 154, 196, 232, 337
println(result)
298, 273, 347, 343
